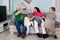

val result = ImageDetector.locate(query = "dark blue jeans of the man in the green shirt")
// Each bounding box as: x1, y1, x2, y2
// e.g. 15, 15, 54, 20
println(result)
15, 20, 27, 35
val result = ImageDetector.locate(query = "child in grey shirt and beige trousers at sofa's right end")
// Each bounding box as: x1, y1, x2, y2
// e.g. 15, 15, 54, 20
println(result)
45, 7, 57, 39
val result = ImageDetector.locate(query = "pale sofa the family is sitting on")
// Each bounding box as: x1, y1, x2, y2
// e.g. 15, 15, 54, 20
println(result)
9, 13, 58, 34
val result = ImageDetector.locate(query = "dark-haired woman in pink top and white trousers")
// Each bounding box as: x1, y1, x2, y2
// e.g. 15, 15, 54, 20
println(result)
32, 7, 47, 38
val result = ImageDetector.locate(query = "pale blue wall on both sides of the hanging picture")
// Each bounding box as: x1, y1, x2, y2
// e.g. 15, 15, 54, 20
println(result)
12, 0, 53, 12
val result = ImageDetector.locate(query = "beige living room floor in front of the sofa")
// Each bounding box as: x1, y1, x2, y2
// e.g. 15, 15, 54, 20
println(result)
0, 28, 60, 40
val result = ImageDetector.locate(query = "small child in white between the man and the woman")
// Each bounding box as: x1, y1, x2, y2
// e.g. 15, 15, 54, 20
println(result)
24, 14, 34, 35
